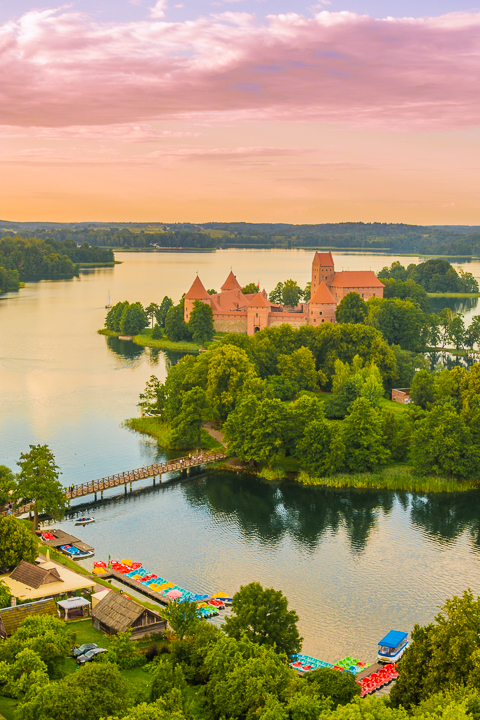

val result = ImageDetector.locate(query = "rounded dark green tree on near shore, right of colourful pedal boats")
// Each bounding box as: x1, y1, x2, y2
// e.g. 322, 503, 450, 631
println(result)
223, 582, 302, 655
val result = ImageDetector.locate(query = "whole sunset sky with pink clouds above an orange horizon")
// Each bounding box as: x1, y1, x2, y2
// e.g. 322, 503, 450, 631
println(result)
0, 0, 480, 225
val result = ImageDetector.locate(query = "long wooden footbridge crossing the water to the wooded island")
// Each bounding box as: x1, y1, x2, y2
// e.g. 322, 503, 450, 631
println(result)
65, 452, 227, 500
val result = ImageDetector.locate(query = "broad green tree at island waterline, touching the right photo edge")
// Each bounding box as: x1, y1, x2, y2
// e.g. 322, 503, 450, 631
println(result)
411, 399, 480, 478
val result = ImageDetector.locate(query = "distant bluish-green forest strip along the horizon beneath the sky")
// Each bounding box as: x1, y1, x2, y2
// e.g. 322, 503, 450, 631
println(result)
0, 221, 480, 255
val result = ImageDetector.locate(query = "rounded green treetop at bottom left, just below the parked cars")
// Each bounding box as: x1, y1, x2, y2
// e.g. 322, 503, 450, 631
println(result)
15, 662, 132, 720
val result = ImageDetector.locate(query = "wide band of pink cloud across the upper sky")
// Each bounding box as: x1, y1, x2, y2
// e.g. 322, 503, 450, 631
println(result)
0, 8, 480, 130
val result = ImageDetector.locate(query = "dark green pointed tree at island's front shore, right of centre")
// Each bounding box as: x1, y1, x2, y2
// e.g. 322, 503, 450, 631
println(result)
343, 397, 390, 472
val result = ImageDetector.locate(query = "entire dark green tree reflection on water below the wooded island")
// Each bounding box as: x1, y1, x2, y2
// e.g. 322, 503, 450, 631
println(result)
183, 473, 480, 554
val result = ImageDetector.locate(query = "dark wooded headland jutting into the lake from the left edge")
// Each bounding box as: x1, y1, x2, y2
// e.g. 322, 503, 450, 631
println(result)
0, 235, 114, 292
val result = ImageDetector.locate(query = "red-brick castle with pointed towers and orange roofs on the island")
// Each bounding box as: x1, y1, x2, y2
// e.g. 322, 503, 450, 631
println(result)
185, 252, 384, 335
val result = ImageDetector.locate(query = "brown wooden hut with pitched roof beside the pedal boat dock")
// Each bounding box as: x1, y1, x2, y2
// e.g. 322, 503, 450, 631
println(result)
92, 592, 167, 640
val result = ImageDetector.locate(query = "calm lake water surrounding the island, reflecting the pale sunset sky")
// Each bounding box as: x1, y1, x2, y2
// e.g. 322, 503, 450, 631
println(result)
0, 250, 480, 661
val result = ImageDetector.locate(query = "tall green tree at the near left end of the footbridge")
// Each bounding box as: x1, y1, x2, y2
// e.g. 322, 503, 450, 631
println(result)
16, 445, 67, 530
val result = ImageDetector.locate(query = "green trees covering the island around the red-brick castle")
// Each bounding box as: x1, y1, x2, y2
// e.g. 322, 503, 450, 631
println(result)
99, 260, 480, 490
